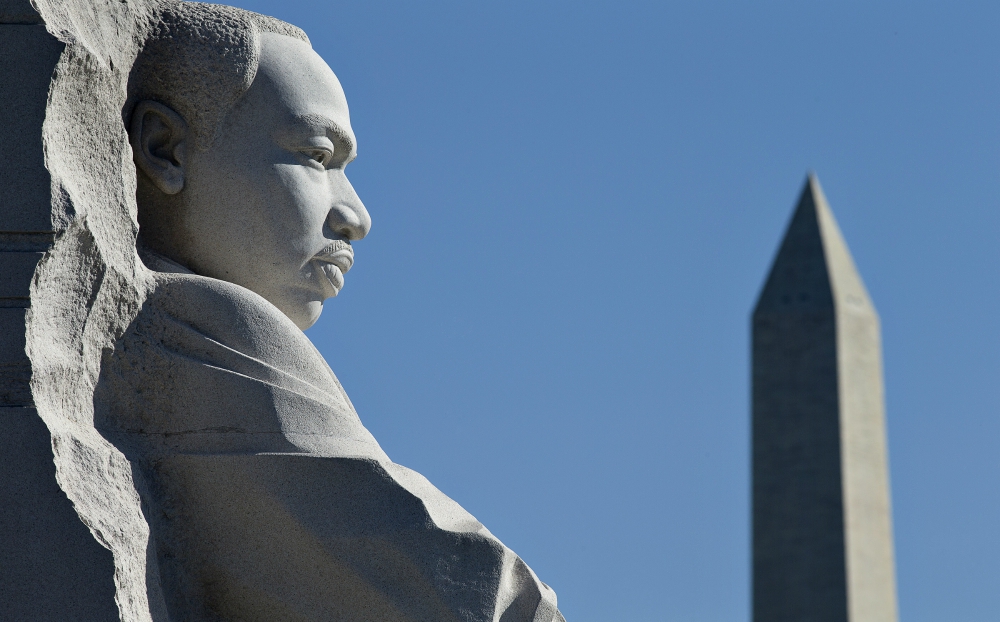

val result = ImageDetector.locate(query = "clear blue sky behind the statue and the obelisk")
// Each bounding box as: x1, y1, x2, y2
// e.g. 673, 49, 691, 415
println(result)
229, 0, 1000, 622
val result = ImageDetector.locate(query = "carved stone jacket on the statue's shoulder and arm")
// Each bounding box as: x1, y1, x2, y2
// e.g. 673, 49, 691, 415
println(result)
95, 258, 564, 622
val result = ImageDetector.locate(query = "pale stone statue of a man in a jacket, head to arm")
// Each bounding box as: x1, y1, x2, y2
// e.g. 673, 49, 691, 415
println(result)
58, 2, 563, 622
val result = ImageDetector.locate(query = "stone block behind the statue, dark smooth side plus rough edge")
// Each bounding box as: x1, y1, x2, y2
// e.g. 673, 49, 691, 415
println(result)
0, 0, 166, 621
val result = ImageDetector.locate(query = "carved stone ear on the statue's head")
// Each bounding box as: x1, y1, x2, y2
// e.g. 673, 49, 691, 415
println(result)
129, 100, 190, 194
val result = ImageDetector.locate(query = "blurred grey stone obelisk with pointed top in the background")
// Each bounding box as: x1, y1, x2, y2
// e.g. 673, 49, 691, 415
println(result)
752, 175, 897, 622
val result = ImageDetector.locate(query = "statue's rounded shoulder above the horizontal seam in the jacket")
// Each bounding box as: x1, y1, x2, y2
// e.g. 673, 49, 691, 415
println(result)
94, 271, 384, 458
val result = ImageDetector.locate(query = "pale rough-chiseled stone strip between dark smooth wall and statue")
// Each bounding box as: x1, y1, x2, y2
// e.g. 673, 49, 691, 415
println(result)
25, 0, 167, 622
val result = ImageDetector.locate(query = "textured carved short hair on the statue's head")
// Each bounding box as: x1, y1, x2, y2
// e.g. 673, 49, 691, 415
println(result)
122, 2, 309, 151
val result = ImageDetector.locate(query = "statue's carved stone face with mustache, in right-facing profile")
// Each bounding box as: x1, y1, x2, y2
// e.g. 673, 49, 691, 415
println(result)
168, 34, 371, 329
